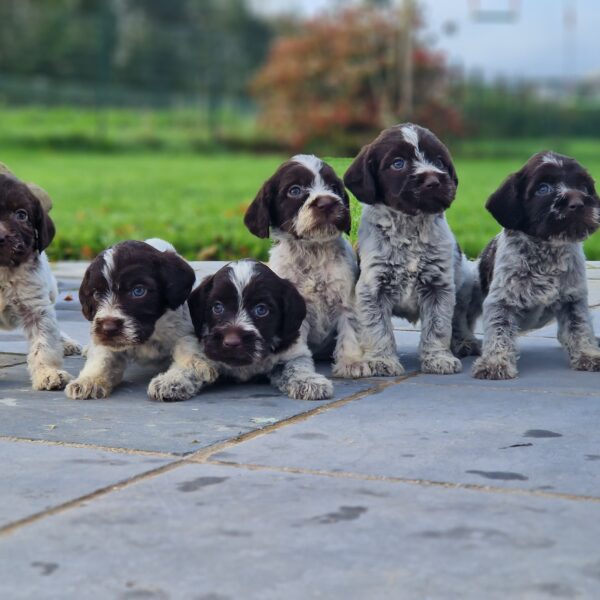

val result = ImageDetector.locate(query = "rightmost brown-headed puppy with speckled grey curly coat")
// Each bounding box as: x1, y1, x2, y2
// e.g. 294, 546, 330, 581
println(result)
473, 152, 600, 379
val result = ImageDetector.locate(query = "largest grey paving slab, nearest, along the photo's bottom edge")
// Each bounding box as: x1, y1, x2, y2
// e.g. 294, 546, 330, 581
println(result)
0, 465, 600, 600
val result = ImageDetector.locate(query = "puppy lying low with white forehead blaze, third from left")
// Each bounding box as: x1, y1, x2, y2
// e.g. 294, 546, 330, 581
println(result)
188, 260, 333, 400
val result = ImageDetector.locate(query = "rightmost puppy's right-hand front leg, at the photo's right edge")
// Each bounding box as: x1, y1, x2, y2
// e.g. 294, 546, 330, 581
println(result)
556, 298, 600, 371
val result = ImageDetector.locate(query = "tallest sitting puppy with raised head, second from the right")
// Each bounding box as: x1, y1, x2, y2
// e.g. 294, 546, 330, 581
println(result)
344, 123, 479, 376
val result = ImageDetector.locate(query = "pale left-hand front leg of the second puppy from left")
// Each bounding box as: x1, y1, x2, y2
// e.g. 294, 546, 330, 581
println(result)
65, 343, 127, 400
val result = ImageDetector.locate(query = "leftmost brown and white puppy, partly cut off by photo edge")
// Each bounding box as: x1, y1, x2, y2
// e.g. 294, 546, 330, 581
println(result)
0, 173, 81, 390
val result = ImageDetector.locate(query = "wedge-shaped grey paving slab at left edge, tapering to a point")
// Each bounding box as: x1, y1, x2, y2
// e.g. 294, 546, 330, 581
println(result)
0, 440, 172, 526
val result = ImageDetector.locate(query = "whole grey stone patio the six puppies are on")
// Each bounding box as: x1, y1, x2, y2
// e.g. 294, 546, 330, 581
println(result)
0, 263, 600, 600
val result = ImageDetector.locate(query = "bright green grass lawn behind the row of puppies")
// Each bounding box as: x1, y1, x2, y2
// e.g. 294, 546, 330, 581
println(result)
0, 142, 600, 260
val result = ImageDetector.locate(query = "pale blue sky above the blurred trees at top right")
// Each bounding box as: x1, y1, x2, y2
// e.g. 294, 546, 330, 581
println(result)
256, 0, 600, 79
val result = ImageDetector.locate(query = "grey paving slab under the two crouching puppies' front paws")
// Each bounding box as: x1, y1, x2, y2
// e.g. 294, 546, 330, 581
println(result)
0, 358, 374, 453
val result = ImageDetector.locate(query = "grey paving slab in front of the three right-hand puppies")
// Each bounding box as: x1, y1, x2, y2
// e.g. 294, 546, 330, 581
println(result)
212, 377, 600, 496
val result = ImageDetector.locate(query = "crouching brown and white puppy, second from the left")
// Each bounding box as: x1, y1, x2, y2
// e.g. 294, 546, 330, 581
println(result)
66, 240, 210, 402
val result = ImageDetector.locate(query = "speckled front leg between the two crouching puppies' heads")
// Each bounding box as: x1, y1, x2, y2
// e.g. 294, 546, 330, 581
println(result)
148, 335, 219, 402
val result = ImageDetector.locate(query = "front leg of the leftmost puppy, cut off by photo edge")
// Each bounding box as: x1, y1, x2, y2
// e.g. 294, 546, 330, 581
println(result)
19, 305, 71, 390
